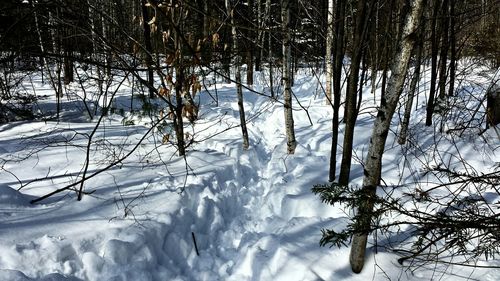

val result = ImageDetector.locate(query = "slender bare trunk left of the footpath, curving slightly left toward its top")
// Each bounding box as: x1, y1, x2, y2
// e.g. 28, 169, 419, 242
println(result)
226, 0, 250, 150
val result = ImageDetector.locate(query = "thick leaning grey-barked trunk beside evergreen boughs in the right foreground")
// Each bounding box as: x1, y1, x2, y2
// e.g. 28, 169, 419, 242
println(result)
350, 0, 425, 273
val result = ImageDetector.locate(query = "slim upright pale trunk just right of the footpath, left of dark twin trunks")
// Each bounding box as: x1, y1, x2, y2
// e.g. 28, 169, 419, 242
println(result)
281, 0, 297, 154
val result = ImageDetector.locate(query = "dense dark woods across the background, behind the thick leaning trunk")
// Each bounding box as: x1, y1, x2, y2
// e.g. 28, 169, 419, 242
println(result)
0, 0, 500, 150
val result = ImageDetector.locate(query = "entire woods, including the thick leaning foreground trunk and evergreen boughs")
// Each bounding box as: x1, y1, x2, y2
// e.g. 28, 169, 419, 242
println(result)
0, 0, 500, 272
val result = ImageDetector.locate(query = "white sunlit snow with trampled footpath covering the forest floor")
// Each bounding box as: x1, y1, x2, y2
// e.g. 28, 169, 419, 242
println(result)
0, 64, 500, 281
